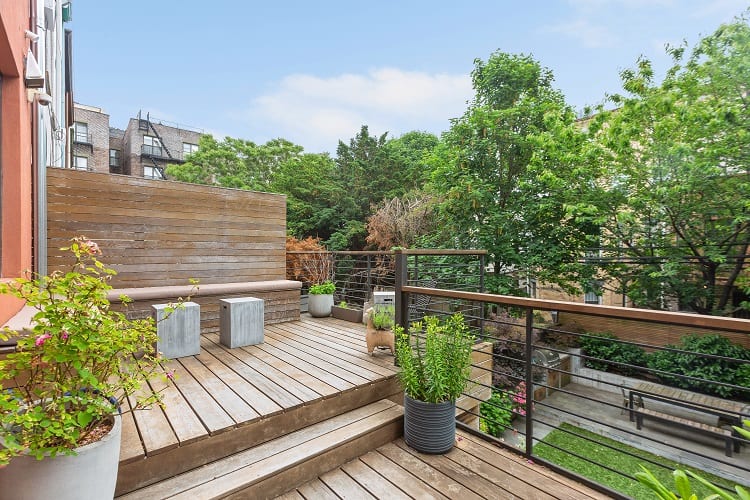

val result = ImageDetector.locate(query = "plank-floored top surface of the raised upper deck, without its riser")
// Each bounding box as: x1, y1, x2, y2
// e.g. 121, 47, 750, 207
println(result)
120, 318, 396, 463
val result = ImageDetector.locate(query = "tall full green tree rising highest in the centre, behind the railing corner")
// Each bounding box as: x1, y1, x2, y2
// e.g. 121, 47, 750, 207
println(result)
430, 52, 593, 293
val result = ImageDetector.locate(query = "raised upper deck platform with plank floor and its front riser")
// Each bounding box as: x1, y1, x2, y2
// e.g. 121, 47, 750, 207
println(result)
118, 317, 400, 494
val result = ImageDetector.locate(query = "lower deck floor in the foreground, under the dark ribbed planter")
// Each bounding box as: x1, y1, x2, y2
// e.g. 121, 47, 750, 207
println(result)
278, 431, 609, 500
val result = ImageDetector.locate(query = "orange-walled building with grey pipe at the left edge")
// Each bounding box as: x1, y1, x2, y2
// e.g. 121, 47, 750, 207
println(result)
0, 0, 73, 324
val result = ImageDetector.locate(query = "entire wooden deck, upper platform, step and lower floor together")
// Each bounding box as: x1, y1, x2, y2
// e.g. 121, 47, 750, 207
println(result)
116, 317, 606, 499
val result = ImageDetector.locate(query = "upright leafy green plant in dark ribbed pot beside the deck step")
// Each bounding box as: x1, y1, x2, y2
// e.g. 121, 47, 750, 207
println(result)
394, 313, 474, 454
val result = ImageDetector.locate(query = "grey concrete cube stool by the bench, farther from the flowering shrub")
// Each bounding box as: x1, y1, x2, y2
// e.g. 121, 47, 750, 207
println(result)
219, 297, 264, 349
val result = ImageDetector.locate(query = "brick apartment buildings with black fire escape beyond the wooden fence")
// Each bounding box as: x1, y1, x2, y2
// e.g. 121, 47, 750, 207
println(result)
72, 103, 203, 179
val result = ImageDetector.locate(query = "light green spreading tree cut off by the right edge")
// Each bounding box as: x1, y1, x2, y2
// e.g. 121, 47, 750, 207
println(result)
572, 19, 750, 315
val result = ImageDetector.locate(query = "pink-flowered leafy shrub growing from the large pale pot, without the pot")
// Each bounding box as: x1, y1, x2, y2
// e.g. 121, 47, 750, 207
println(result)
0, 237, 179, 464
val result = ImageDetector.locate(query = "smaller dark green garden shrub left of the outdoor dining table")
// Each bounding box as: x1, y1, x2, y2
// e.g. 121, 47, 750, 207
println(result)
580, 333, 646, 375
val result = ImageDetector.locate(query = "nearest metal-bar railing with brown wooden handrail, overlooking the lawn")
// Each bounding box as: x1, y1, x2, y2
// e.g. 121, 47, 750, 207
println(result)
395, 266, 750, 497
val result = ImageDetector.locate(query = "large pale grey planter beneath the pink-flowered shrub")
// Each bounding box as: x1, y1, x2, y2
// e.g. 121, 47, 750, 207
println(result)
0, 415, 122, 500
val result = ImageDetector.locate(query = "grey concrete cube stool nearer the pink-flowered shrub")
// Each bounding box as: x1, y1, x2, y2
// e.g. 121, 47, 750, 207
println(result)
151, 302, 201, 358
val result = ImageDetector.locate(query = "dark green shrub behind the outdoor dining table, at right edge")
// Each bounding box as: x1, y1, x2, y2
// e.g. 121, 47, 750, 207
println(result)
648, 335, 750, 398
